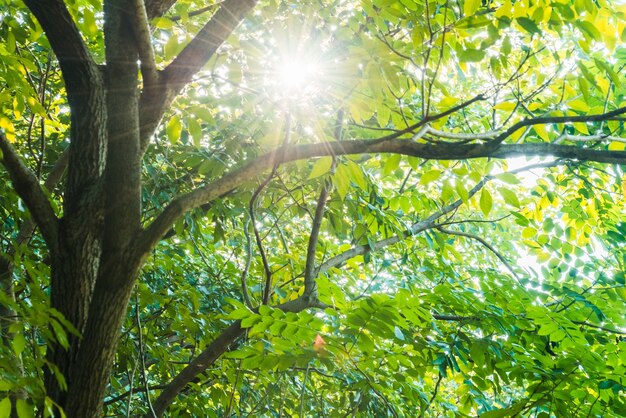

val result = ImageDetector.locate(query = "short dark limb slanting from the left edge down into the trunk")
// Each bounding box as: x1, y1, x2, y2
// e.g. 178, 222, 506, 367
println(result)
0, 133, 58, 252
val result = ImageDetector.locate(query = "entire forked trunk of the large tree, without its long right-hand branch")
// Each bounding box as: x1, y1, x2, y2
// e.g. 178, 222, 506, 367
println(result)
7, 0, 255, 417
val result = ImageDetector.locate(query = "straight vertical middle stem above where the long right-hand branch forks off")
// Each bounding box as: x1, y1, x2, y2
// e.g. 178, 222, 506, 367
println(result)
103, 0, 145, 255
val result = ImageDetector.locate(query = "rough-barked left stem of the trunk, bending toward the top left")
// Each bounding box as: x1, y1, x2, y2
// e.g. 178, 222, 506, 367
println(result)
25, 0, 107, 406
